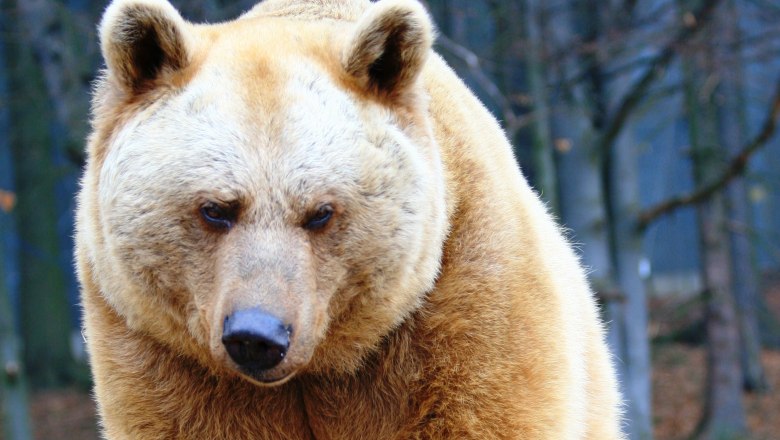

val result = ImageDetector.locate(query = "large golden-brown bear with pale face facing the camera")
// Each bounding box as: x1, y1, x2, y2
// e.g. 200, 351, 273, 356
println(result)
76, 0, 621, 440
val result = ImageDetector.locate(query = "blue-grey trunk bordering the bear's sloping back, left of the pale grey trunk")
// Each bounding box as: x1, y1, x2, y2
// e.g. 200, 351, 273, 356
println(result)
542, 0, 628, 400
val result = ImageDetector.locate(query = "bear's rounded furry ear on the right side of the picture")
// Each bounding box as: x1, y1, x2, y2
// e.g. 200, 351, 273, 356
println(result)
342, 0, 433, 96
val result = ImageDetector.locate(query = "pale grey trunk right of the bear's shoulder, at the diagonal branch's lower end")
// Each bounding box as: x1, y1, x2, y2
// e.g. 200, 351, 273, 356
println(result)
597, 1, 656, 440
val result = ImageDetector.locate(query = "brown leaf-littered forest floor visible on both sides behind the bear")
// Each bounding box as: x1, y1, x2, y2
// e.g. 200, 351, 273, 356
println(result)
9, 279, 780, 440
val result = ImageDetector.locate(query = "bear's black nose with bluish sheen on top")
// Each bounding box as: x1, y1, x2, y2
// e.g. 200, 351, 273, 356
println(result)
222, 308, 291, 374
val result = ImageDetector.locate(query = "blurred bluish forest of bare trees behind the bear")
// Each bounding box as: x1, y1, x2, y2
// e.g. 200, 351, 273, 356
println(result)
0, 0, 780, 440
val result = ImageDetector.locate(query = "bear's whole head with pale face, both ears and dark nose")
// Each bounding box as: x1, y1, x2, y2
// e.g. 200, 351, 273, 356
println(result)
88, 0, 445, 384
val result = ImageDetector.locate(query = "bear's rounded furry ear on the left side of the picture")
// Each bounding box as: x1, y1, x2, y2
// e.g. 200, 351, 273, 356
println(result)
99, 0, 190, 94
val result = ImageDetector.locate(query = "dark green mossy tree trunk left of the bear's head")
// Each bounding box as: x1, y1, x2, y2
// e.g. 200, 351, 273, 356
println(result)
9, 1, 73, 386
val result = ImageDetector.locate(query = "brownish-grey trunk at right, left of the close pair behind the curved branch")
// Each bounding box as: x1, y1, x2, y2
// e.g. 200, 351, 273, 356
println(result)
684, 9, 747, 434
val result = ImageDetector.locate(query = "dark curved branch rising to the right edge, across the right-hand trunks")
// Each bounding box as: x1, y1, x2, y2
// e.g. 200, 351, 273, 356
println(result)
637, 79, 780, 230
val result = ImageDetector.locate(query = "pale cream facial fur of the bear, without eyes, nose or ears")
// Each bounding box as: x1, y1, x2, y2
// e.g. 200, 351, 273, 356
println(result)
87, 0, 445, 384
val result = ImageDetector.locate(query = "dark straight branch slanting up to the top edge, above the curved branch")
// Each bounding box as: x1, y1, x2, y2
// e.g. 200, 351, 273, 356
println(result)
599, 0, 720, 148
